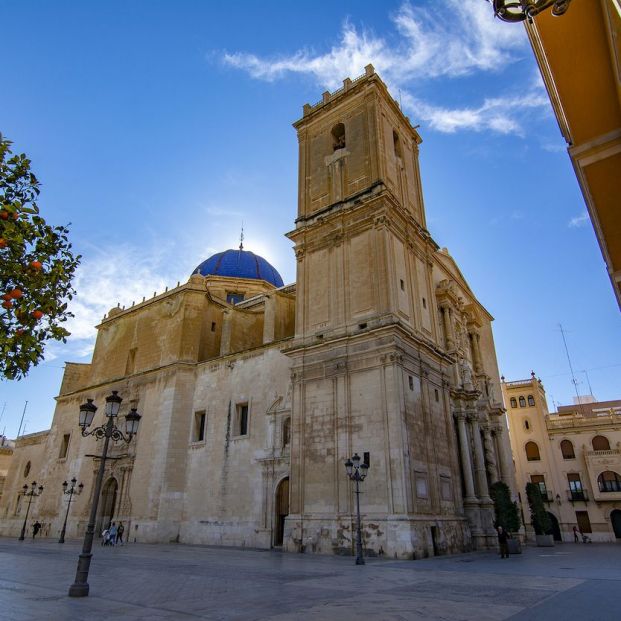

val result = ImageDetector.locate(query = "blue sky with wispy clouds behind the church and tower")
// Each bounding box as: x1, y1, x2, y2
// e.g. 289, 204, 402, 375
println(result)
0, 0, 621, 436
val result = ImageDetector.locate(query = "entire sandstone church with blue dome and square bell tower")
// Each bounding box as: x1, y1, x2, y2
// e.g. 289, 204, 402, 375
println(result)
0, 65, 515, 559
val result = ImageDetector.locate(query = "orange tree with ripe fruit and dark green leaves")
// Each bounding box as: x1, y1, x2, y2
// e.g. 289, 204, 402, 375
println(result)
0, 134, 80, 379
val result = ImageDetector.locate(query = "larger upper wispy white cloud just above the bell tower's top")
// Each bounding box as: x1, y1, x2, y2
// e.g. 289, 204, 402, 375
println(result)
223, 0, 526, 89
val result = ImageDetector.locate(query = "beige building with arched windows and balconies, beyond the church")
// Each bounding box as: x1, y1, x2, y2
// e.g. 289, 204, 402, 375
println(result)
502, 373, 621, 541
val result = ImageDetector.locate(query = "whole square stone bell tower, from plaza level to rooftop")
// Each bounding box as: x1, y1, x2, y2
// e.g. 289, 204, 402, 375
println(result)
285, 65, 478, 558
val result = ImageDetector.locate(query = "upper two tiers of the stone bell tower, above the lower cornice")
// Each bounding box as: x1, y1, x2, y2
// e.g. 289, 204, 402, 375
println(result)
288, 65, 437, 340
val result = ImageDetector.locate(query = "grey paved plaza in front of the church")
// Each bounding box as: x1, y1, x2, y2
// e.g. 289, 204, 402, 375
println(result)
0, 538, 621, 621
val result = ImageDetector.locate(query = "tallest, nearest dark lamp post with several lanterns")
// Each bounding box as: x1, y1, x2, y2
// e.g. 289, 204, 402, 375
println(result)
69, 390, 142, 597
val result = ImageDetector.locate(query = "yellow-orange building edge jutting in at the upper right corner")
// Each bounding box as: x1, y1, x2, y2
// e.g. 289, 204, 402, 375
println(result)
524, 0, 621, 306
